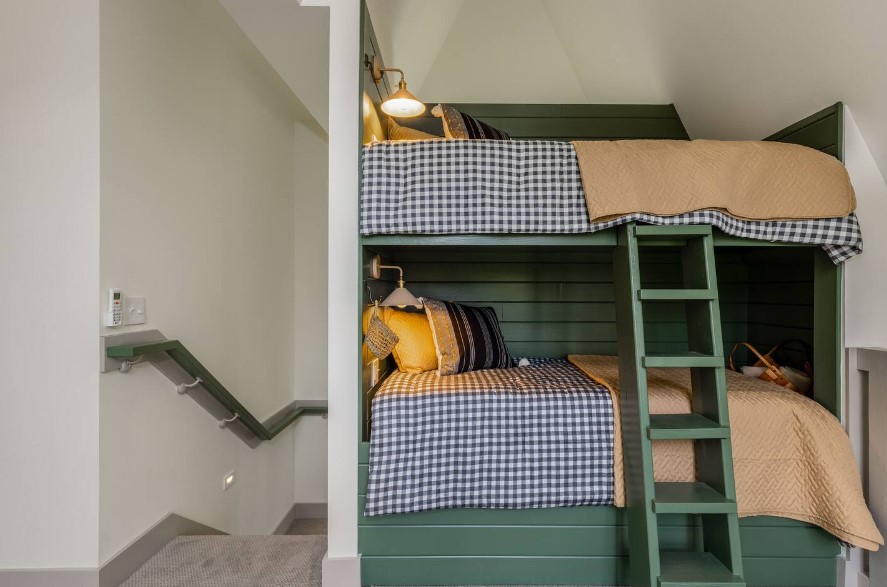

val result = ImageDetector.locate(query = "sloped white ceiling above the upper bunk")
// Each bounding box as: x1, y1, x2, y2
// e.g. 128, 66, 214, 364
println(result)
369, 0, 887, 173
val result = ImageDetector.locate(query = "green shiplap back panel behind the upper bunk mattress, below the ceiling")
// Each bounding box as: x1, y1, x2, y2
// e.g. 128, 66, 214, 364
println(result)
397, 104, 689, 141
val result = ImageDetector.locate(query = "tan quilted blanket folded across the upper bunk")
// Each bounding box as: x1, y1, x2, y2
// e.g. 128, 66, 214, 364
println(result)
573, 140, 856, 222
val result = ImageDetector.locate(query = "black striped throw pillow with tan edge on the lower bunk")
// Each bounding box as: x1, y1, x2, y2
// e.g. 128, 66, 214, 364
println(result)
422, 299, 511, 375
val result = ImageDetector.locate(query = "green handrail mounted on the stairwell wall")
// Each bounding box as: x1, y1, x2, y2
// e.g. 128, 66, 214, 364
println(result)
106, 340, 327, 440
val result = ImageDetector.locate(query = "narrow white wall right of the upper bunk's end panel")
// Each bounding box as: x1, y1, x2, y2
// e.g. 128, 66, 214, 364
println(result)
844, 107, 887, 348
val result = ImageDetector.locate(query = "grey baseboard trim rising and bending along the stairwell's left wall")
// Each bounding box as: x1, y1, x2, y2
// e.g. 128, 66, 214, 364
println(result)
98, 514, 225, 587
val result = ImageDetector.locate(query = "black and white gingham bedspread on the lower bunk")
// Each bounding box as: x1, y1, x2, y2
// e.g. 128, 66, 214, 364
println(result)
365, 359, 613, 516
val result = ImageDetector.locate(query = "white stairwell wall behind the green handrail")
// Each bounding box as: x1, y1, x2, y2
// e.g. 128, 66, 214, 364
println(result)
100, 0, 326, 562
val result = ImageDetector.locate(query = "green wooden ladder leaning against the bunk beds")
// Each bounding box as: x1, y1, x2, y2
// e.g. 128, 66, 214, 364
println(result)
614, 224, 745, 587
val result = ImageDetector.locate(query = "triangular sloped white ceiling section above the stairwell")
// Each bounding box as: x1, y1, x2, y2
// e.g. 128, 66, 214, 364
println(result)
219, 0, 330, 130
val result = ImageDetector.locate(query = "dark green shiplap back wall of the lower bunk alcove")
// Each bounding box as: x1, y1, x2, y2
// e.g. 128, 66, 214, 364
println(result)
374, 247, 748, 357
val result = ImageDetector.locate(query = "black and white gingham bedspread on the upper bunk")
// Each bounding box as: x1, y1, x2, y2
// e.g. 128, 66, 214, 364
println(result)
360, 141, 862, 263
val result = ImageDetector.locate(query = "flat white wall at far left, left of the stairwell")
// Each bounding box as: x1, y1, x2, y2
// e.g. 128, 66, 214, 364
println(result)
0, 0, 99, 569
